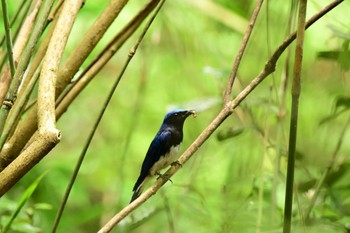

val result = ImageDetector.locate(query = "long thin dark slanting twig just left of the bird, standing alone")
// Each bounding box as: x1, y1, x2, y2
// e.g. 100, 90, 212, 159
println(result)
52, 0, 164, 233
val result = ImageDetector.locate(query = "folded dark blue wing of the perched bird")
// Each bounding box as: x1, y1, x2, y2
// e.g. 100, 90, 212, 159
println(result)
133, 129, 175, 191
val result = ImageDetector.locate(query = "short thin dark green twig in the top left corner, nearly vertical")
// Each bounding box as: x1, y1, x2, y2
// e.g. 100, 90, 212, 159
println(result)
0, 0, 16, 76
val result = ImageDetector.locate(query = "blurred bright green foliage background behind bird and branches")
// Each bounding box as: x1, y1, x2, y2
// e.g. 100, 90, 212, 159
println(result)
0, 0, 350, 233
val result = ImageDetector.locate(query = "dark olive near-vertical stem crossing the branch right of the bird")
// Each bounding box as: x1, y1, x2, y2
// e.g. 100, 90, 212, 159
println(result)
283, 0, 307, 233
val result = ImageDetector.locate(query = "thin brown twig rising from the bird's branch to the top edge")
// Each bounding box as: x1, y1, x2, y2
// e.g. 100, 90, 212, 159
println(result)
224, 0, 264, 104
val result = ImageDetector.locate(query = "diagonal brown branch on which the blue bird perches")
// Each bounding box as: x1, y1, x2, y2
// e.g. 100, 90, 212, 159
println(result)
99, 0, 344, 233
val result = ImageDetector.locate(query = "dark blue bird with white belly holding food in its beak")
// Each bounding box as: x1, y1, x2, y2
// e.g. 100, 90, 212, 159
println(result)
130, 109, 196, 203
